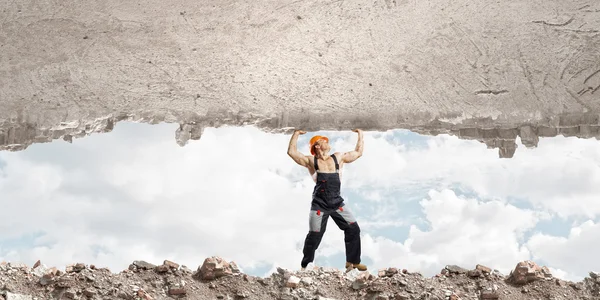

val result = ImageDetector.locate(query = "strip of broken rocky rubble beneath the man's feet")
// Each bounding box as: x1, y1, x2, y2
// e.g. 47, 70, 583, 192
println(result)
0, 257, 600, 300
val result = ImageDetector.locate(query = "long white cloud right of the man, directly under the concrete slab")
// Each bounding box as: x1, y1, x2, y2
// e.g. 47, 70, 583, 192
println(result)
335, 131, 600, 218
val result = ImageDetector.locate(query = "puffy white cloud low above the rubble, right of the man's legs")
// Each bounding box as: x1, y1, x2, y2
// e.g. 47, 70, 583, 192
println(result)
366, 190, 544, 276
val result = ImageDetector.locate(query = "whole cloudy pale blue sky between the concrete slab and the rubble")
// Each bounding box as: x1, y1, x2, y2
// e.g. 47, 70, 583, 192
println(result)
0, 122, 600, 281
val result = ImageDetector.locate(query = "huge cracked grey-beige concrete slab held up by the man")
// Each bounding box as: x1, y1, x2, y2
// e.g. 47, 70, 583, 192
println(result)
0, 0, 600, 157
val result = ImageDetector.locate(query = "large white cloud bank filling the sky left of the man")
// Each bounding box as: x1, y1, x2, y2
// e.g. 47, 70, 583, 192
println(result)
0, 125, 313, 270
